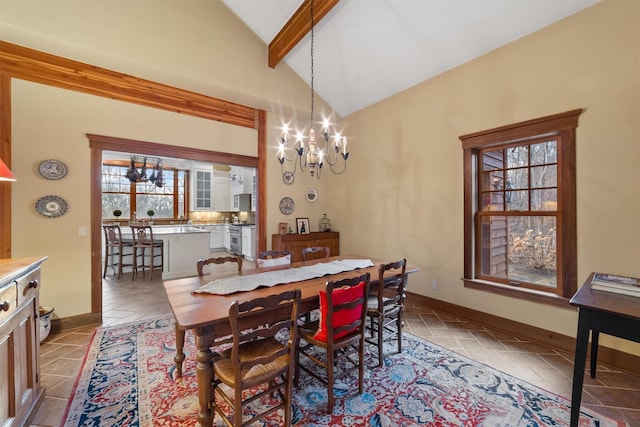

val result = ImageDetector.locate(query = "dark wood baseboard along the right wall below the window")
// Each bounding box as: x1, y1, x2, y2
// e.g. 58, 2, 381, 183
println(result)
407, 292, 640, 374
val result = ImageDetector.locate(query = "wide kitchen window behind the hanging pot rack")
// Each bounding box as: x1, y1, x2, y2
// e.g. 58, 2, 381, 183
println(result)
102, 164, 188, 219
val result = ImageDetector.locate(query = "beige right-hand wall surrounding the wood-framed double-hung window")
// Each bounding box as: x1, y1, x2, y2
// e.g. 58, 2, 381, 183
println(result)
334, 0, 640, 354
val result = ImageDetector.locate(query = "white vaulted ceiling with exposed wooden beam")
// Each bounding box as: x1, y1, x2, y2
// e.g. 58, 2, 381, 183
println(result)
222, 0, 600, 116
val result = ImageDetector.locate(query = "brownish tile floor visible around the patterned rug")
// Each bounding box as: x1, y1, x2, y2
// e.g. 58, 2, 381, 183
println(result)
31, 266, 640, 426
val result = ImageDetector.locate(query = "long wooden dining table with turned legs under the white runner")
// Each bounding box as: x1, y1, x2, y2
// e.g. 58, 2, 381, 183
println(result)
164, 255, 417, 427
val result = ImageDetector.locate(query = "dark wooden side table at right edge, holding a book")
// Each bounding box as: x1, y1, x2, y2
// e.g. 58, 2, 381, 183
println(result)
569, 273, 640, 427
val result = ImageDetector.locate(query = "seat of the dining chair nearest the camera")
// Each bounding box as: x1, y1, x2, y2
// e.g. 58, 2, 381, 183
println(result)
213, 338, 289, 388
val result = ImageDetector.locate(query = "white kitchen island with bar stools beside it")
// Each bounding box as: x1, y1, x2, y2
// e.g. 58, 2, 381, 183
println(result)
122, 225, 210, 280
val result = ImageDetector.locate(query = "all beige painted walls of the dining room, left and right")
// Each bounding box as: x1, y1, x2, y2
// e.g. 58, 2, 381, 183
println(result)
0, 0, 640, 354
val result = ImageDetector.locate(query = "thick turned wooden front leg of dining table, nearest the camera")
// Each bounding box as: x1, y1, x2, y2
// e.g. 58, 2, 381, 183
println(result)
194, 328, 214, 427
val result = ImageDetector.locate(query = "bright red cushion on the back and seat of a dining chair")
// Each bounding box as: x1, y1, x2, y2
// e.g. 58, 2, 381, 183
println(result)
313, 282, 365, 341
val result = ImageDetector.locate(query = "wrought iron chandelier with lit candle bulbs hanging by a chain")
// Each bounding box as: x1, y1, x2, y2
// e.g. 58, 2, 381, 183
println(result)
278, 0, 349, 182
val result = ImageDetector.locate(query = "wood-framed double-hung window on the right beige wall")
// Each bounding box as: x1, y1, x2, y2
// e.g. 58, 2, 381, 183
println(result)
460, 110, 581, 305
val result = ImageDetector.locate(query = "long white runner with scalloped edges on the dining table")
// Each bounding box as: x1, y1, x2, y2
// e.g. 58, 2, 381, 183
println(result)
192, 259, 373, 295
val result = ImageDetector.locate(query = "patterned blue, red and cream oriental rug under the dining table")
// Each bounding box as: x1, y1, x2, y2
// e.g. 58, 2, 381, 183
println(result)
62, 316, 626, 427
